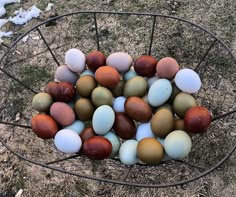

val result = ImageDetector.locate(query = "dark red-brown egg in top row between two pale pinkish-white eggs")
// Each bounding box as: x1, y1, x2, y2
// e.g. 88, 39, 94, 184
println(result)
86, 51, 106, 72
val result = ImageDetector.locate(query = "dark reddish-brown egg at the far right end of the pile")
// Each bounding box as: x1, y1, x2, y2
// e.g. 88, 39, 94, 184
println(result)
184, 106, 211, 133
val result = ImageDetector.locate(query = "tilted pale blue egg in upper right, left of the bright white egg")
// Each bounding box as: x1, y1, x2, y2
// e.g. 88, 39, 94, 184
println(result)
148, 79, 172, 107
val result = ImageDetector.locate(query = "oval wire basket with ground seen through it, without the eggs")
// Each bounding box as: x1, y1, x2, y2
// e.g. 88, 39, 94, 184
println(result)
0, 11, 236, 188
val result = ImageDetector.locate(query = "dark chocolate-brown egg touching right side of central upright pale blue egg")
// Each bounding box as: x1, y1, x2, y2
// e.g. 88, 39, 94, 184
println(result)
113, 113, 136, 139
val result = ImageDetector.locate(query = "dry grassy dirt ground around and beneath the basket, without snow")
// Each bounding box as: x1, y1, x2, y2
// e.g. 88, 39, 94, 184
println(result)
0, 0, 236, 197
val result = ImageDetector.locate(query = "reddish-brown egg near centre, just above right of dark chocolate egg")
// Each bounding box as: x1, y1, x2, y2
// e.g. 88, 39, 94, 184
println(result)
125, 97, 152, 122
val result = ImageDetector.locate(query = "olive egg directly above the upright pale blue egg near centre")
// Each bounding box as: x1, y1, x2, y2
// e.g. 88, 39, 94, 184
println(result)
91, 87, 113, 107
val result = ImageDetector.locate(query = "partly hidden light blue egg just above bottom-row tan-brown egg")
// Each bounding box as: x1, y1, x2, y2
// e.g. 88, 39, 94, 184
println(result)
135, 122, 156, 141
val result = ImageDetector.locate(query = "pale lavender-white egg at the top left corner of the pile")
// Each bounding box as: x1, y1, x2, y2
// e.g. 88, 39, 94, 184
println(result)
65, 48, 86, 73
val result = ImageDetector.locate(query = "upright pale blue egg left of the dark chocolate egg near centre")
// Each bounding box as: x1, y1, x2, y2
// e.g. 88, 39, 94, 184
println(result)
92, 105, 115, 135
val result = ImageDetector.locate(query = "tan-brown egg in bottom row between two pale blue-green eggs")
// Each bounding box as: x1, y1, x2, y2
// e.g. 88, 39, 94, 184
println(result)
137, 138, 164, 164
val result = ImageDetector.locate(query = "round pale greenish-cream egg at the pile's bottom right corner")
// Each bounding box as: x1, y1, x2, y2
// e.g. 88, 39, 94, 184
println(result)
164, 130, 192, 159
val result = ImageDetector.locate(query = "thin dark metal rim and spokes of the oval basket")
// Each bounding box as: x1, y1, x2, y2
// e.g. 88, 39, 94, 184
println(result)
0, 11, 236, 188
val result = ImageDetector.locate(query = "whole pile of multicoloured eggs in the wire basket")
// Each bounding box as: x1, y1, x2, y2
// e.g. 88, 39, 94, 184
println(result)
31, 48, 211, 165
